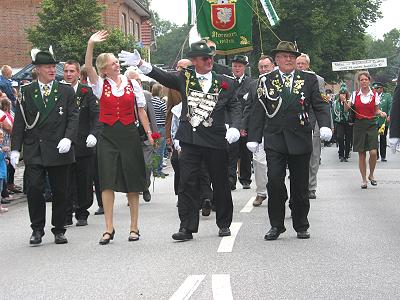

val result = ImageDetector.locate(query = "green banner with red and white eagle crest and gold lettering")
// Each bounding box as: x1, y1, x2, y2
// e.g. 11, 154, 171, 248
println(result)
188, 0, 253, 55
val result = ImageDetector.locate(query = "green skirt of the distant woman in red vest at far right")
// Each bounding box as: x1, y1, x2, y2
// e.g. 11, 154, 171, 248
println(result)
353, 119, 378, 152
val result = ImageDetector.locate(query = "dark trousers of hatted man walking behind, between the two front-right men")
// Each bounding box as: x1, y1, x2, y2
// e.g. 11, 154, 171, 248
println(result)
228, 136, 253, 184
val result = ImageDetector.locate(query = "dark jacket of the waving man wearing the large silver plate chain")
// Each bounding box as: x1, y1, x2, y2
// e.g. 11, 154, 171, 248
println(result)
147, 66, 241, 148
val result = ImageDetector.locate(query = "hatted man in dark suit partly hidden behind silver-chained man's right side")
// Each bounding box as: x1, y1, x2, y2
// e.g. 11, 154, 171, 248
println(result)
228, 55, 253, 190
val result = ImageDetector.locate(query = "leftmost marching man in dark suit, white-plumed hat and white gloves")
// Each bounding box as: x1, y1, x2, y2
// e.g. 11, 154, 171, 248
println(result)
11, 48, 79, 245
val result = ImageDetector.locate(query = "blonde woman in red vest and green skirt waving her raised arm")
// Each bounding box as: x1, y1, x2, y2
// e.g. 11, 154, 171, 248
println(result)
85, 31, 153, 245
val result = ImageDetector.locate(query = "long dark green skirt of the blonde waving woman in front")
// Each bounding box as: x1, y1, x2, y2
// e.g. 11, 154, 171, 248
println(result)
97, 121, 146, 193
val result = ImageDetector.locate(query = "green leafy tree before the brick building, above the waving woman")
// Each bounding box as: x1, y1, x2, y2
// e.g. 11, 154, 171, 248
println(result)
27, 0, 136, 63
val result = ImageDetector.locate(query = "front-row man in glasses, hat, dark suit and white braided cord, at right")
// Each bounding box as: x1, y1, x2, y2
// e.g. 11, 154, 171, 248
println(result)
247, 41, 332, 240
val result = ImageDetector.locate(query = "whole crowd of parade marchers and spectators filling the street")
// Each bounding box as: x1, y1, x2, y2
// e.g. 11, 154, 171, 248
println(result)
0, 31, 400, 245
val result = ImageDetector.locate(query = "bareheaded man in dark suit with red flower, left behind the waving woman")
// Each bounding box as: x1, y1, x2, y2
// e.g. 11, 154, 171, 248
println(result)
64, 60, 101, 226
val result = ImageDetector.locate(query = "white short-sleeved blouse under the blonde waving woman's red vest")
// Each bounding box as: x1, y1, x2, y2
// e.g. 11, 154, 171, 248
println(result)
90, 75, 146, 107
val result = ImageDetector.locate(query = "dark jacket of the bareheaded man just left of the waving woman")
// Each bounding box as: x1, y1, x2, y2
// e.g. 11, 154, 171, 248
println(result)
75, 83, 102, 157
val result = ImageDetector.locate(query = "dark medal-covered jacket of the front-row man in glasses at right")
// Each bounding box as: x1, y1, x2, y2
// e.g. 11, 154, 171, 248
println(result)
248, 70, 331, 155
